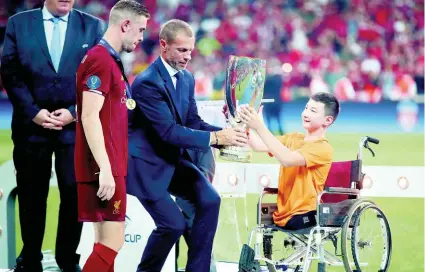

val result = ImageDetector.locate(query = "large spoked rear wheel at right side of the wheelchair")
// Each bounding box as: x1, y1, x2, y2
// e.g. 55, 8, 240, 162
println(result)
341, 199, 391, 272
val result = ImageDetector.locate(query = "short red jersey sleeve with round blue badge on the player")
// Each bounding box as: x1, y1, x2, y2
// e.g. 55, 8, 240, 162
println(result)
82, 55, 112, 96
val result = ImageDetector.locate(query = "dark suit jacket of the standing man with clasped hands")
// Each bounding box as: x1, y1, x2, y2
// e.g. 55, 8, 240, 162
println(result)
0, 9, 103, 144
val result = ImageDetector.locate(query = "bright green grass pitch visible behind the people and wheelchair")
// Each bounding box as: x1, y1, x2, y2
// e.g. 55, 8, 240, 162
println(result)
0, 130, 424, 272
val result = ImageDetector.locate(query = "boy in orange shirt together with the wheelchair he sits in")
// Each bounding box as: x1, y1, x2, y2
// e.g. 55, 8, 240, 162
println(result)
239, 93, 392, 272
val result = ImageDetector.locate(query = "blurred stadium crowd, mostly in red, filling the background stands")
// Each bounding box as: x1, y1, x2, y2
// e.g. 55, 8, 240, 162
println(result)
0, 0, 424, 103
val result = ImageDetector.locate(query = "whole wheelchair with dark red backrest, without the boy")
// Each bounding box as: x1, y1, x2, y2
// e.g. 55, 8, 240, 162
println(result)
239, 136, 392, 272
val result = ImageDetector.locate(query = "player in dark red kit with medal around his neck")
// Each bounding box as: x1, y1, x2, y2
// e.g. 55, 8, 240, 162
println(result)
74, 0, 150, 272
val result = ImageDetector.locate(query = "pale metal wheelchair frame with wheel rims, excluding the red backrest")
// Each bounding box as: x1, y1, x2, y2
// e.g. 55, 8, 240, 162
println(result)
239, 136, 391, 272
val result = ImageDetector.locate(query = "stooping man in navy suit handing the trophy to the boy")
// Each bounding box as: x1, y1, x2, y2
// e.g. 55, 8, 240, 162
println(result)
127, 20, 247, 272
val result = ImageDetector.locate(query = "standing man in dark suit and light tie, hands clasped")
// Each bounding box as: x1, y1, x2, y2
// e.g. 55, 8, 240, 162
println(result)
1, 0, 103, 272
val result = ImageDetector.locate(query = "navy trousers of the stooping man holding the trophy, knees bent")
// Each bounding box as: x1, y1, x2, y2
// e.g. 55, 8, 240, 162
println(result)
137, 159, 220, 272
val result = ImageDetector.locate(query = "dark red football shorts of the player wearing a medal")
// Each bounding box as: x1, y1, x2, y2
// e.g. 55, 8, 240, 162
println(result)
77, 177, 127, 222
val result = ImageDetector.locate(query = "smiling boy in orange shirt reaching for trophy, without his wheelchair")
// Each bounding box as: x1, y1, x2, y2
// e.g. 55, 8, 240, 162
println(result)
239, 93, 340, 230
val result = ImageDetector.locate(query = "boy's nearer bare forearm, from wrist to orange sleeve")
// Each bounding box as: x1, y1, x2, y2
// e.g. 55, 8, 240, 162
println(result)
255, 123, 306, 167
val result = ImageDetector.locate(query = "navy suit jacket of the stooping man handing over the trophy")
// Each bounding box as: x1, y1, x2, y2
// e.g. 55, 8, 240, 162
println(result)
127, 58, 221, 200
